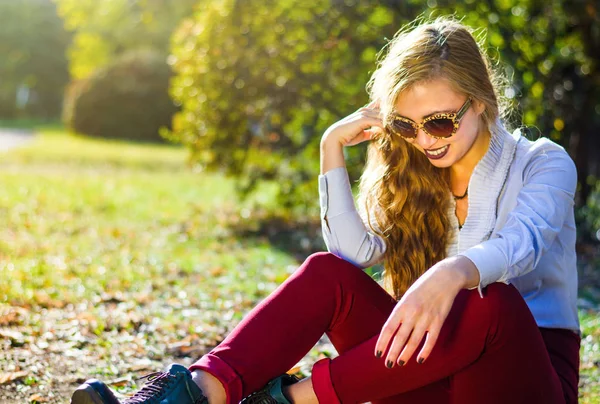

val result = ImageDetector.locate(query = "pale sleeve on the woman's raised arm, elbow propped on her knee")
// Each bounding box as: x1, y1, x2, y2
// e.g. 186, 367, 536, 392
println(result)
319, 167, 386, 268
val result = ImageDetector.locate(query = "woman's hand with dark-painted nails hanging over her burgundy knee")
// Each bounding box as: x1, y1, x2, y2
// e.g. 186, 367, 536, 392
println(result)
375, 256, 479, 368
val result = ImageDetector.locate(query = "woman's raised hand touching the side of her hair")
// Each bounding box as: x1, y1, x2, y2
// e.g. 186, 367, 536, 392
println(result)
321, 101, 383, 146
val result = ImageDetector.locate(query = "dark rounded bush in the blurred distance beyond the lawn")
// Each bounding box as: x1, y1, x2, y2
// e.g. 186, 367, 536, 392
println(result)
64, 51, 176, 142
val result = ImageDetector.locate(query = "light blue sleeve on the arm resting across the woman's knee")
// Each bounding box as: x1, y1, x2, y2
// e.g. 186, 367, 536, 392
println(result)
459, 141, 577, 296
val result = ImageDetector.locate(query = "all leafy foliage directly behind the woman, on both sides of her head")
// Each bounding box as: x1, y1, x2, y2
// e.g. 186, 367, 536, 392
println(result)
169, 0, 600, 218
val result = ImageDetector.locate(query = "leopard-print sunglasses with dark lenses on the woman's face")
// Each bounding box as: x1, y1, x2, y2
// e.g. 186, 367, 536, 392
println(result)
385, 97, 471, 139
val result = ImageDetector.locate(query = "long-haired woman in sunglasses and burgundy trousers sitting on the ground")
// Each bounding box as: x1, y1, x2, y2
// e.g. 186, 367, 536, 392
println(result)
72, 19, 580, 404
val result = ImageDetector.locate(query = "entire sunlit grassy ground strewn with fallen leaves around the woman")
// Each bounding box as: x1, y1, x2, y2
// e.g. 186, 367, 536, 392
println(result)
0, 129, 600, 403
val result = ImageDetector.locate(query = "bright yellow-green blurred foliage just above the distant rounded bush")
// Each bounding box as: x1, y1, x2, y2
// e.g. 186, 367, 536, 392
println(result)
54, 0, 196, 79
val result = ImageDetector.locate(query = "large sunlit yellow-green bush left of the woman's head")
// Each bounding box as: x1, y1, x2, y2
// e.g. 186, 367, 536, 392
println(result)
170, 0, 406, 215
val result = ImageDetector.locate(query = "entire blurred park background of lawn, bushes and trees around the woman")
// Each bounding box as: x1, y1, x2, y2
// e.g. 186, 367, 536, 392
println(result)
0, 0, 600, 403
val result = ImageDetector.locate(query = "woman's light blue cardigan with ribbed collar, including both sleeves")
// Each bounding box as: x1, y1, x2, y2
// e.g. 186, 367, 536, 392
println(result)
319, 121, 581, 334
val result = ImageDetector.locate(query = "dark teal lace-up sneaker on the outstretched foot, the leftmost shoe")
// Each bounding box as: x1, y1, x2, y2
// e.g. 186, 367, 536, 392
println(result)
71, 364, 208, 404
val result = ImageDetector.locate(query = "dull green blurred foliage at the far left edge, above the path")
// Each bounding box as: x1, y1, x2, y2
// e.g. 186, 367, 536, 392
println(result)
0, 0, 69, 119
